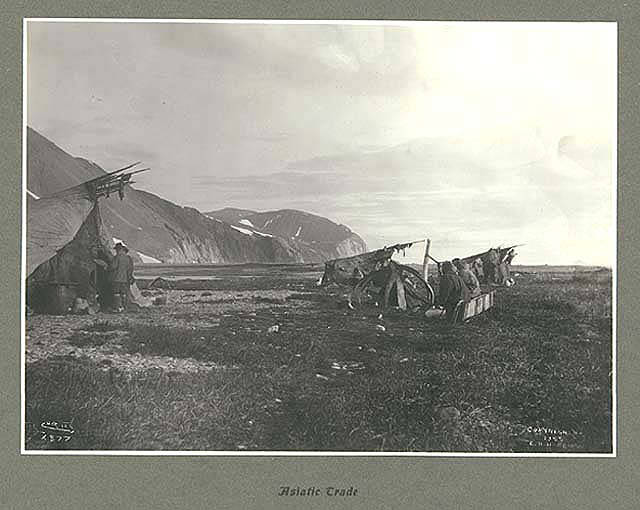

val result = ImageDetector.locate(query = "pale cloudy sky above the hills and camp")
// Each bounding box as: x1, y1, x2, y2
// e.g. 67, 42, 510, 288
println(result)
27, 22, 616, 265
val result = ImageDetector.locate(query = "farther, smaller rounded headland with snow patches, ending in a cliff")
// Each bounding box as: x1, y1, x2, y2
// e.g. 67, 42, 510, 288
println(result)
205, 207, 367, 260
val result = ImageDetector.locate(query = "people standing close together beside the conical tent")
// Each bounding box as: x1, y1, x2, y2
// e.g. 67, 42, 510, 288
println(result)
94, 242, 135, 312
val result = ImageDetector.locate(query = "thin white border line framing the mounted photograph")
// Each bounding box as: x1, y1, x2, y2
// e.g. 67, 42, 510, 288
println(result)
20, 18, 618, 458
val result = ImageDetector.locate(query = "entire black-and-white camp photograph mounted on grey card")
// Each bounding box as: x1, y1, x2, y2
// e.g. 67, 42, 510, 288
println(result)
21, 18, 618, 454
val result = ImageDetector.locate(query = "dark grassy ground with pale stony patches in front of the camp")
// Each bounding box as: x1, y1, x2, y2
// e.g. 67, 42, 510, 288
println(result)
26, 266, 612, 453
